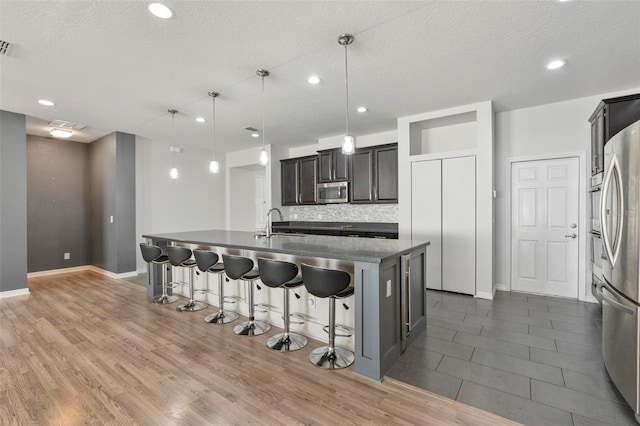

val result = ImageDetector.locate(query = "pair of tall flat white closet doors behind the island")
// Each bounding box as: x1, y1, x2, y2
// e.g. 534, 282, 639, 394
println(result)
411, 156, 476, 295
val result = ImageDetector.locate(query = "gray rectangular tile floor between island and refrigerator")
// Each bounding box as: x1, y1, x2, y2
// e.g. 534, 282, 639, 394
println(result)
389, 291, 636, 425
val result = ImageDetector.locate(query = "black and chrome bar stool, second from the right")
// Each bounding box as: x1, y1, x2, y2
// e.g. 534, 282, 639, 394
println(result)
258, 258, 307, 352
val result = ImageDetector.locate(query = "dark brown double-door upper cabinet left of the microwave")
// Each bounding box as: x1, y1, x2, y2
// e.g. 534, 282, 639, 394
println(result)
280, 155, 318, 206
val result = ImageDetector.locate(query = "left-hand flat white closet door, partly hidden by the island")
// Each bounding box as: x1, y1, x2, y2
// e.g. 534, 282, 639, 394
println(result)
411, 160, 442, 290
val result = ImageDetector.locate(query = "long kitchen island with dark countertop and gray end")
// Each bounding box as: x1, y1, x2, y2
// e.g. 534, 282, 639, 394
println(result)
143, 230, 429, 381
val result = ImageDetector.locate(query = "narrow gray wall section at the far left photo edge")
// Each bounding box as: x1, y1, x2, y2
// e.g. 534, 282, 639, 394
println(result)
0, 110, 27, 291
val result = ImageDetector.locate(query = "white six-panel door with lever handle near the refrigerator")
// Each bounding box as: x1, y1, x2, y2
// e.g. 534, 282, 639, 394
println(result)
511, 157, 579, 298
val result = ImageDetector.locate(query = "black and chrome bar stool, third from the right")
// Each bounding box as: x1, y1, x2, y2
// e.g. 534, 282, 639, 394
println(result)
222, 254, 271, 336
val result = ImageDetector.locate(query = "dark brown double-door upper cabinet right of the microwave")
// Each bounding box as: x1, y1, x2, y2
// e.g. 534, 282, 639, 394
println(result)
351, 144, 398, 204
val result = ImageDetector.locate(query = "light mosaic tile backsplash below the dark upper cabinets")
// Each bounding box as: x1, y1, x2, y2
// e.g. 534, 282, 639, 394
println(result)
289, 204, 398, 222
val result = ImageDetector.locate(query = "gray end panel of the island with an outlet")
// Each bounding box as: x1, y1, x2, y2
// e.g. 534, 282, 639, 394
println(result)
354, 257, 401, 381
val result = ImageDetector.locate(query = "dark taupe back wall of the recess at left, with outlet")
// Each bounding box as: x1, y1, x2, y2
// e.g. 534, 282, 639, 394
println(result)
27, 135, 89, 272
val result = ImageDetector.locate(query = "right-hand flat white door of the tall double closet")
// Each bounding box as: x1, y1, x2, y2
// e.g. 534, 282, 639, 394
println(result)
442, 157, 476, 294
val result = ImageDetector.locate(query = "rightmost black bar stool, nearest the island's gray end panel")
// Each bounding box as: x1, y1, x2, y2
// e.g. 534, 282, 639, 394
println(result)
302, 263, 355, 370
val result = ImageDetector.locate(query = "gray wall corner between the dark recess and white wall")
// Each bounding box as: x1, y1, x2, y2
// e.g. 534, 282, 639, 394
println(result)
89, 132, 136, 273
